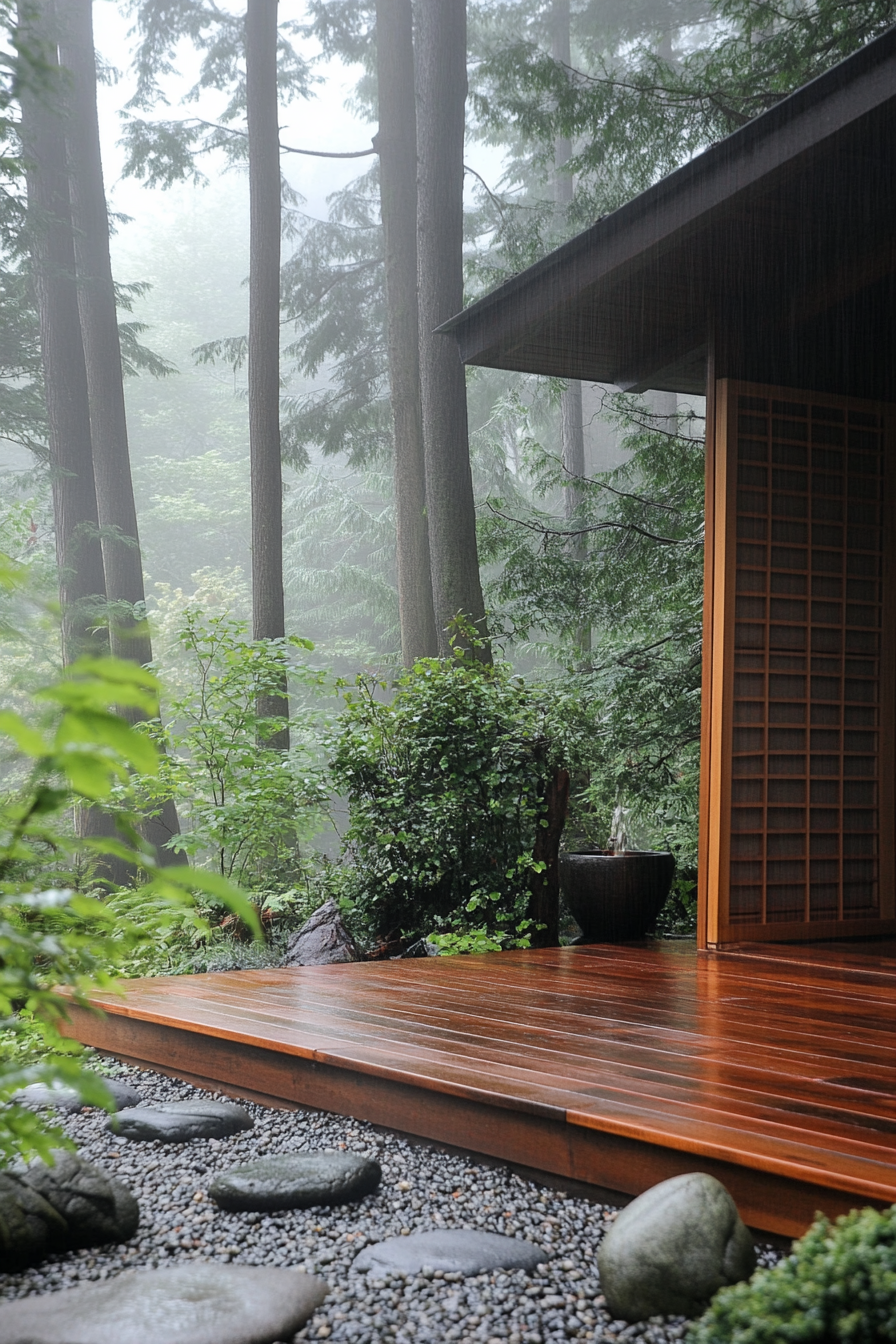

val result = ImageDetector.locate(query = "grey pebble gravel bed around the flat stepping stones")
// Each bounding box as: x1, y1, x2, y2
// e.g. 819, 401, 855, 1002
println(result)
0, 1066, 776, 1344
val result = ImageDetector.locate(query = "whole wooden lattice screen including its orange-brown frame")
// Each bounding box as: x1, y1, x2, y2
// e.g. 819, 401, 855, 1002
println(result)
704, 380, 893, 942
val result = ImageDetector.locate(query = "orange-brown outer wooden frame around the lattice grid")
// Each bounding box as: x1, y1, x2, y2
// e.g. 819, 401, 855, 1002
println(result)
697, 376, 896, 949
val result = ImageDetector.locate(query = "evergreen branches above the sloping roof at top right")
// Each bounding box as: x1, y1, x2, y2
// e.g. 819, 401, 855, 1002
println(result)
472, 0, 896, 273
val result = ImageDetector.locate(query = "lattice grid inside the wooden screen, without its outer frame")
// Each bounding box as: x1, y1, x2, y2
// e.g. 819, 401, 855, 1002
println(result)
729, 395, 883, 923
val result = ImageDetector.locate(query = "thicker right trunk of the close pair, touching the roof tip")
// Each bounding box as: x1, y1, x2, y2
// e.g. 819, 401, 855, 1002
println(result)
416, 0, 490, 659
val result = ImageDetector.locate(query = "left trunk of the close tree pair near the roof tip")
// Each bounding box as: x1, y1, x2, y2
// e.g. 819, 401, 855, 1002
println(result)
375, 0, 438, 667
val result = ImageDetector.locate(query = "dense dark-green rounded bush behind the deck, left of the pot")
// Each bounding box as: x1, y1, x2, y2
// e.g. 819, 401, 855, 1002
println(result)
333, 648, 570, 950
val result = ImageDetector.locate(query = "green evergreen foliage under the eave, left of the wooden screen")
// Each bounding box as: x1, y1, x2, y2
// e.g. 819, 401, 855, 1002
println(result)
481, 395, 704, 871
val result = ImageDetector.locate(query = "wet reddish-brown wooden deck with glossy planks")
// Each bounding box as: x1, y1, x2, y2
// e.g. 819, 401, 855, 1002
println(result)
63, 942, 896, 1235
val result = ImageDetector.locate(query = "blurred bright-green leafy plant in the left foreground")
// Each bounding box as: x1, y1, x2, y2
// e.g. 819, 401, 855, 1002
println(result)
0, 555, 258, 1167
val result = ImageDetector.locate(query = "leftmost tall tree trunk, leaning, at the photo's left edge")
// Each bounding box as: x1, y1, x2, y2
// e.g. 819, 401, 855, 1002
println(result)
19, 0, 107, 664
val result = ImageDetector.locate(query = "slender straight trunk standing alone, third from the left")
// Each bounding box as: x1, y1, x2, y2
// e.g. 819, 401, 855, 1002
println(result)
246, 0, 289, 750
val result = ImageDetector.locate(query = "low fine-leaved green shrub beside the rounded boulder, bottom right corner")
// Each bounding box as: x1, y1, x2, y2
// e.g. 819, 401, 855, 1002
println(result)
688, 1206, 896, 1344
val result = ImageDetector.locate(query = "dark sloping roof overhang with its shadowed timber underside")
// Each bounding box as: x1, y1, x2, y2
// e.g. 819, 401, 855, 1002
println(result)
438, 28, 896, 392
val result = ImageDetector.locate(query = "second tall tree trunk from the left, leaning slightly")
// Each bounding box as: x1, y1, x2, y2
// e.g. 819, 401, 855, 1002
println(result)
58, 0, 185, 863
